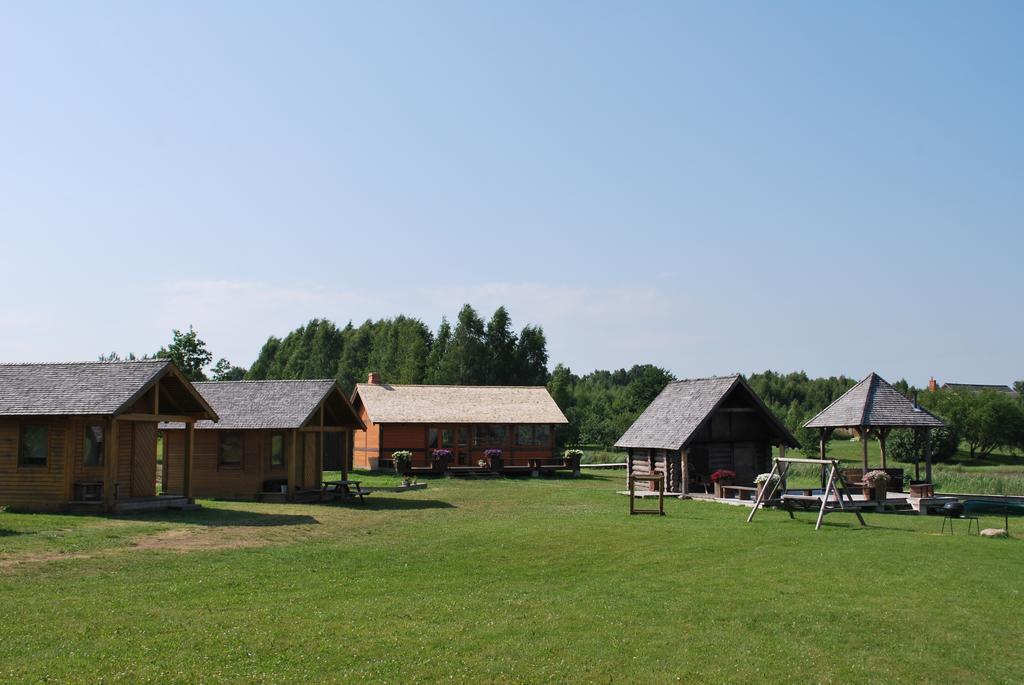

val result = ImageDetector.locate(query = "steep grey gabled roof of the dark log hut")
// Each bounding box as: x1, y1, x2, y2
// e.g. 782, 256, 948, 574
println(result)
615, 375, 798, 449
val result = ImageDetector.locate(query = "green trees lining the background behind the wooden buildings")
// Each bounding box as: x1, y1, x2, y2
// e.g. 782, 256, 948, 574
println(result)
123, 319, 1024, 461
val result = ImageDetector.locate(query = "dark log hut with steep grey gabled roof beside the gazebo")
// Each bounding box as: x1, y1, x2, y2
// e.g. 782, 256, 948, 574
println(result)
615, 375, 798, 494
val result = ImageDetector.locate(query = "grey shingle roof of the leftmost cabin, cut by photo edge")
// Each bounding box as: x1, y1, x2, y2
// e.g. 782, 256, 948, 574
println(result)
0, 359, 171, 416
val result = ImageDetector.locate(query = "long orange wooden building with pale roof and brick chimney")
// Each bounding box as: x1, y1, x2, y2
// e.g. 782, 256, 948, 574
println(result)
352, 374, 568, 473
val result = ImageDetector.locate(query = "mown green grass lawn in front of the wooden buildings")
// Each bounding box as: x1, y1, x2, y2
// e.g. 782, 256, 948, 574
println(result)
0, 471, 1024, 683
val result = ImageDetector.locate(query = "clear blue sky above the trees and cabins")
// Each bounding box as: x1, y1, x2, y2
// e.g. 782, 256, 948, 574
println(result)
0, 2, 1024, 384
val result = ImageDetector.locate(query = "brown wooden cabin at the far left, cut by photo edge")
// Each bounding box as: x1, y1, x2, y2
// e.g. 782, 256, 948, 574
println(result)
0, 359, 217, 511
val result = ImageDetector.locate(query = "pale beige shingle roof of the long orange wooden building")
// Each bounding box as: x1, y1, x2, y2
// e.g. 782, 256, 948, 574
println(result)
353, 383, 568, 424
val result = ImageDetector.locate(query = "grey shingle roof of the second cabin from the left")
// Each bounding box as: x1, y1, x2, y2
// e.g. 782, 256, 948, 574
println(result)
162, 379, 344, 430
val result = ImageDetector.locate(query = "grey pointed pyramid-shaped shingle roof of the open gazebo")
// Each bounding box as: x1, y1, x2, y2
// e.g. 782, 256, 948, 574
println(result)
805, 372, 945, 428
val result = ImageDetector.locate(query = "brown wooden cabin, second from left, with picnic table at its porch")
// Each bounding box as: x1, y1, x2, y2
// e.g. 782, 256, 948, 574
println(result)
161, 380, 364, 500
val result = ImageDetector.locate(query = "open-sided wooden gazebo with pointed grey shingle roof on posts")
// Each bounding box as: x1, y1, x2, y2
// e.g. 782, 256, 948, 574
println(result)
804, 372, 945, 482
